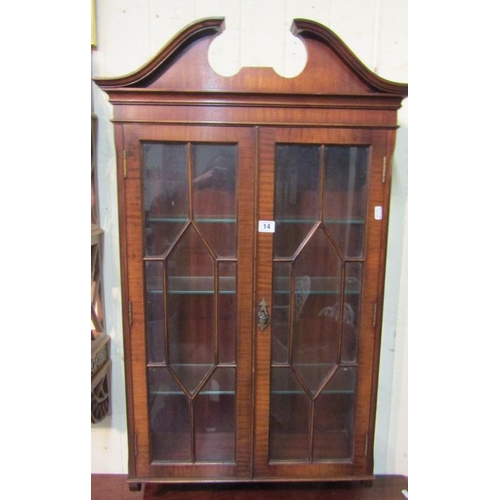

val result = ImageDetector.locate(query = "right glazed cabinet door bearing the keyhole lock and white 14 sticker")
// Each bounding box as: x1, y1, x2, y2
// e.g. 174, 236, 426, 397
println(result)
254, 128, 388, 479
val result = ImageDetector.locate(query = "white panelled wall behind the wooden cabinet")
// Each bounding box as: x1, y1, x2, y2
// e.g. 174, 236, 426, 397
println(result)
92, 0, 408, 475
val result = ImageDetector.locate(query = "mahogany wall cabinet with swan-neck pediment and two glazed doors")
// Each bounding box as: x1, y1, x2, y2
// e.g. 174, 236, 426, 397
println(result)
95, 19, 407, 490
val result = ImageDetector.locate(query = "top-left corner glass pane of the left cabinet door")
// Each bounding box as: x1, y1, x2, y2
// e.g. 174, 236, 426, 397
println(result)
143, 143, 189, 255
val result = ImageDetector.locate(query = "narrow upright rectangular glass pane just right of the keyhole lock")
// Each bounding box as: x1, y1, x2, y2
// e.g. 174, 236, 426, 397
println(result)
271, 262, 292, 364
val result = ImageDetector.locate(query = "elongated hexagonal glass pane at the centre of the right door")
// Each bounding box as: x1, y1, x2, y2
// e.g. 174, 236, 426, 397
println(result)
292, 228, 341, 394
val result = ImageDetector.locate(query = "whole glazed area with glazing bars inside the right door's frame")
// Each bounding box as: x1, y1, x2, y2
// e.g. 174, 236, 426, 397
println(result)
270, 141, 369, 461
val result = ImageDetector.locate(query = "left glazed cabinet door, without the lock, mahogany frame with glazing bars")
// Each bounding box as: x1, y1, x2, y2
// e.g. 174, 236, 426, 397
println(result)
121, 124, 255, 480
